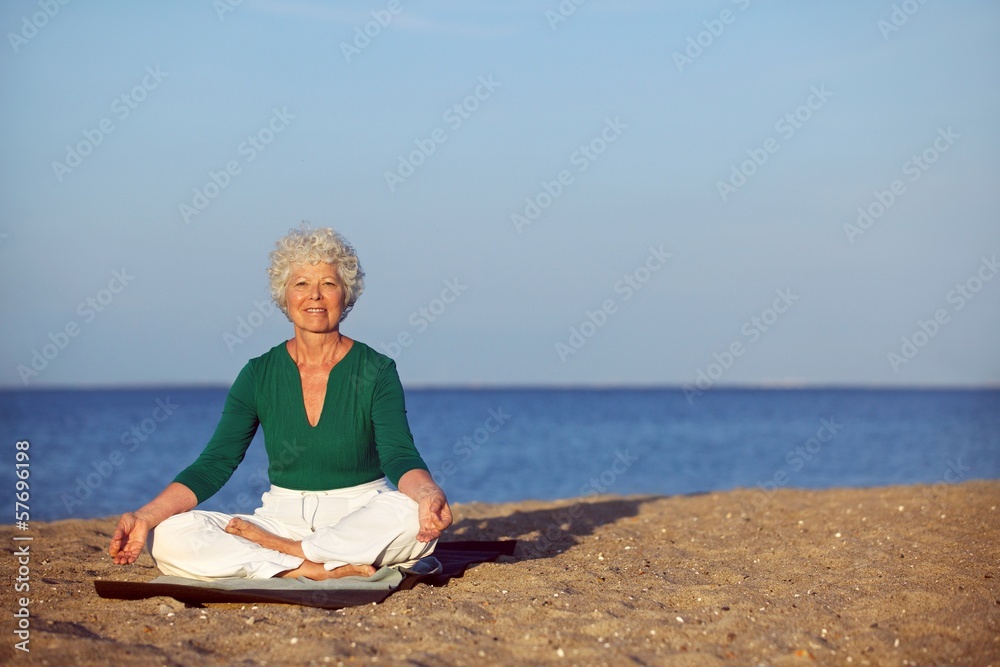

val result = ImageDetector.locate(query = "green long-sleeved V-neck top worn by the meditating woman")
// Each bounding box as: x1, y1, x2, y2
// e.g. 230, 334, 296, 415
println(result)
174, 341, 427, 503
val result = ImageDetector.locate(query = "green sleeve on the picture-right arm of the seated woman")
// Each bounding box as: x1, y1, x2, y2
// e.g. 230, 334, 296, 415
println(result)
372, 358, 427, 486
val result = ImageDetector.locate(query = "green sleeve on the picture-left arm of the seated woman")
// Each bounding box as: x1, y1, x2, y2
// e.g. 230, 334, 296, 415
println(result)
174, 363, 260, 503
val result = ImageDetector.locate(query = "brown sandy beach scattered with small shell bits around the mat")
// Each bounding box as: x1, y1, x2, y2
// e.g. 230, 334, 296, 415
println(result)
0, 481, 1000, 667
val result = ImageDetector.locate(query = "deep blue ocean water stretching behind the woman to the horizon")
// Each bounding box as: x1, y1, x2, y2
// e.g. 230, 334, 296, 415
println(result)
0, 387, 1000, 524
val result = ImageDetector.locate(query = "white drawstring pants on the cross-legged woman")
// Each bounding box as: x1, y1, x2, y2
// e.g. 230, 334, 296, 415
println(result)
149, 478, 437, 581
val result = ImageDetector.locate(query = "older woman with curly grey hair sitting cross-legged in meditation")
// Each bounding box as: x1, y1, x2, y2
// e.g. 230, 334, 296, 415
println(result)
108, 227, 452, 580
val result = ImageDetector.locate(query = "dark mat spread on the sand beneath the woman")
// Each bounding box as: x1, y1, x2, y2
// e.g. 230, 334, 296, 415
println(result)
94, 540, 517, 609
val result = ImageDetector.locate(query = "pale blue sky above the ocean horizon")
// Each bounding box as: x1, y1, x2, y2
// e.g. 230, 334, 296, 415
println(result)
0, 0, 1000, 388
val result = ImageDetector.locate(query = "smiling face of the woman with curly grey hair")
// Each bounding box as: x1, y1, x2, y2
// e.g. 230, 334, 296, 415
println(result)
285, 262, 344, 333
